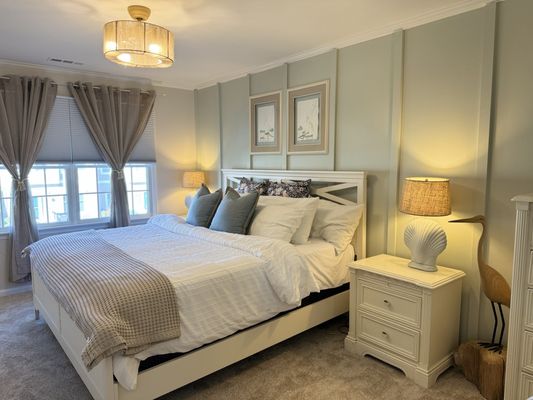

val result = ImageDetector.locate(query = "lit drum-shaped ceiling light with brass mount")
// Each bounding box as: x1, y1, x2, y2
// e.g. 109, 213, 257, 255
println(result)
104, 6, 174, 68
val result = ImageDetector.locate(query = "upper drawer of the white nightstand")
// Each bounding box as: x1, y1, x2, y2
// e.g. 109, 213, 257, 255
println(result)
357, 279, 422, 328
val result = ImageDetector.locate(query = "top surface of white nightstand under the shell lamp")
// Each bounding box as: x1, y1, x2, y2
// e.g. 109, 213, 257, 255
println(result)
350, 254, 465, 289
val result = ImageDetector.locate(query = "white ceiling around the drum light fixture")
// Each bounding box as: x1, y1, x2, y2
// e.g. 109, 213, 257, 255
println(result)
0, 0, 486, 89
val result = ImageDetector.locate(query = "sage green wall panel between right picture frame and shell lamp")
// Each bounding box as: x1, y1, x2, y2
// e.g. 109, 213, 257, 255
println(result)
335, 36, 393, 255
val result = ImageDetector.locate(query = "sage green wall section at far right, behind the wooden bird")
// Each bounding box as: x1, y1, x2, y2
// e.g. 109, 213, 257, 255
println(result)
481, 0, 533, 344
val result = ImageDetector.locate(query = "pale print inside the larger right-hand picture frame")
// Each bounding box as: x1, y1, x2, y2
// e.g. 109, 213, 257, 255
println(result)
294, 94, 320, 144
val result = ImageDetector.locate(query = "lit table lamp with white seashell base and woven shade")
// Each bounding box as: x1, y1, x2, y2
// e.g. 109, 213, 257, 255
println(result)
400, 177, 451, 272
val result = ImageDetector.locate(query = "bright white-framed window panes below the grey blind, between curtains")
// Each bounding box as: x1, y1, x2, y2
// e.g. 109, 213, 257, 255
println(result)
0, 163, 153, 229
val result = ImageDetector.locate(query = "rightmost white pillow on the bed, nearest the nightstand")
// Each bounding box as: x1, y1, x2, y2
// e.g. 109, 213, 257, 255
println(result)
311, 200, 364, 255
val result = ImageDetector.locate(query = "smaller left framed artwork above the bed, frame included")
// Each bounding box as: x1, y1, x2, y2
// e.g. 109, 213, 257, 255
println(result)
250, 91, 281, 154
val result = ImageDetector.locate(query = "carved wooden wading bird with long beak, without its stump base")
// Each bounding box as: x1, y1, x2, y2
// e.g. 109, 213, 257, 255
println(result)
450, 215, 511, 352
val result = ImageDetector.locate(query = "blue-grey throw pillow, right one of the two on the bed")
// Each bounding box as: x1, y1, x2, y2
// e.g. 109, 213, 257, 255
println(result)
209, 187, 259, 235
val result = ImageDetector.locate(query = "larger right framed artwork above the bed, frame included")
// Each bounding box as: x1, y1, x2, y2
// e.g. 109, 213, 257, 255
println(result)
287, 81, 329, 154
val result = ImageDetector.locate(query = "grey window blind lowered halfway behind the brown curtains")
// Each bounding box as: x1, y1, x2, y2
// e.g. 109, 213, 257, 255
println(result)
37, 96, 155, 163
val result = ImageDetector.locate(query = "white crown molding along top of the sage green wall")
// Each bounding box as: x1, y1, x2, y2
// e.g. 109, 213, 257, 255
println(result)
195, 0, 492, 89
